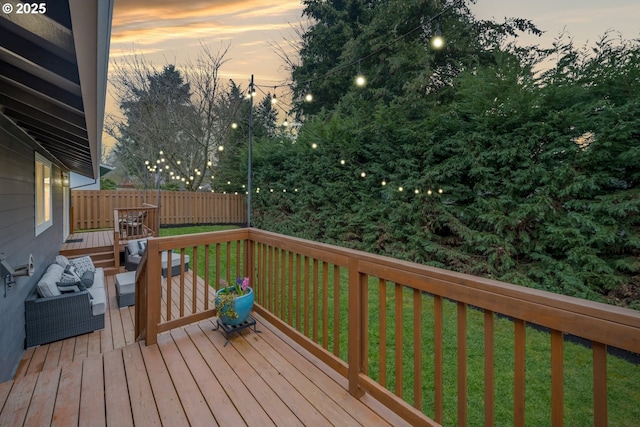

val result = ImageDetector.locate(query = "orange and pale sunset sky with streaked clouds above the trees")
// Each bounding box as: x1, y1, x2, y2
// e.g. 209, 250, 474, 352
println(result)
104, 0, 640, 153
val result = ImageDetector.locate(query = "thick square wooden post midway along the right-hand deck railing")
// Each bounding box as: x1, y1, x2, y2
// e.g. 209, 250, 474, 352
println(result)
347, 258, 364, 398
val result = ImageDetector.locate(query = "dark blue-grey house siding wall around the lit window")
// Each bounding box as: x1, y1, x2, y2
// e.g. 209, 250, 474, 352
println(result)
0, 118, 63, 382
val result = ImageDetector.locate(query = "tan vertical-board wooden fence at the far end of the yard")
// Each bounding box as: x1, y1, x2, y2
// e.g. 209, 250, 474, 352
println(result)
71, 190, 247, 230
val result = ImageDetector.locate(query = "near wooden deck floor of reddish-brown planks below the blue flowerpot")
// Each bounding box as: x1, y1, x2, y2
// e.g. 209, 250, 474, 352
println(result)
0, 276, 406, 426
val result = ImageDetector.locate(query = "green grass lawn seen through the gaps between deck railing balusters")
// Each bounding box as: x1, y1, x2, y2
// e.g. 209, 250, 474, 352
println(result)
160, 226, 640, 427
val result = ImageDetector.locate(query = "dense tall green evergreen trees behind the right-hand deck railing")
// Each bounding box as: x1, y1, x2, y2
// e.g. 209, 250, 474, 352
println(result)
254, 0, 640, 307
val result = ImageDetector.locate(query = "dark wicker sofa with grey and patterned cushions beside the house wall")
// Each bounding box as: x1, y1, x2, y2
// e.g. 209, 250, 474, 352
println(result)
25, 257, 106, 348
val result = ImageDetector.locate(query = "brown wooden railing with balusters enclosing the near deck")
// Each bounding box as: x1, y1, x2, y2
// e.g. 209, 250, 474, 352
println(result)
136, 229, 640, 426
